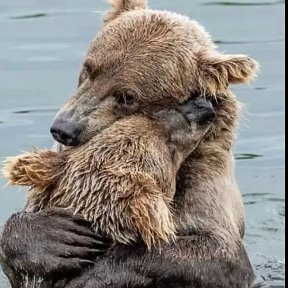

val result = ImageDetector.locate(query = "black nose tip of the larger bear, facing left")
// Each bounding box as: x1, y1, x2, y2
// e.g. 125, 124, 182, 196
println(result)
50, 121, 81, 146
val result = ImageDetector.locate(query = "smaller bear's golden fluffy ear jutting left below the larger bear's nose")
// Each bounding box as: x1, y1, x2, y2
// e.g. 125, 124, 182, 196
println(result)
3, 150, 65, 188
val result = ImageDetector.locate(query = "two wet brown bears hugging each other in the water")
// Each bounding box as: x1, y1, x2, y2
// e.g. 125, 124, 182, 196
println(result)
0, 0, 257, 288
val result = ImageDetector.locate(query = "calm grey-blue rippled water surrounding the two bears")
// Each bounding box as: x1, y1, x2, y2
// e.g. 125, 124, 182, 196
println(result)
0, 0, 285, 288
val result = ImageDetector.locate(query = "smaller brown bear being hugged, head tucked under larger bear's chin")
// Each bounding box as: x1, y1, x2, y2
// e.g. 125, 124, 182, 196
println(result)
4, 98, 215, 249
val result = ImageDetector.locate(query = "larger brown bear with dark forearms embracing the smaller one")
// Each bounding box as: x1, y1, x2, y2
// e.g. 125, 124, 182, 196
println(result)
0, 0, 257, 288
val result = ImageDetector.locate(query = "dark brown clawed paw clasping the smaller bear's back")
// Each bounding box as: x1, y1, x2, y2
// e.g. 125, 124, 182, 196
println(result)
0, 208, 111, 288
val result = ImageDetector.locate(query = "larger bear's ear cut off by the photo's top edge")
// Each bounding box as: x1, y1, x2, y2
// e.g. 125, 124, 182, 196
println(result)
104, 0, 147, 23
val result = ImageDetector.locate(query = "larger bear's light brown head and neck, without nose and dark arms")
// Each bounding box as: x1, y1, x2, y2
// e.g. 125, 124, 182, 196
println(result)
48, 0, 258, 249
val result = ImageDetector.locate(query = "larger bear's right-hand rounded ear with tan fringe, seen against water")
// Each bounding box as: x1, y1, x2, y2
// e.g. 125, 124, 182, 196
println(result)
198, 54, 259, 95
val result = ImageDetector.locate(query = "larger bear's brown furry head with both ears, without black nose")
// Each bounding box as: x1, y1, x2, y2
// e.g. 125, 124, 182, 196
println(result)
54, 0, 257, 145
